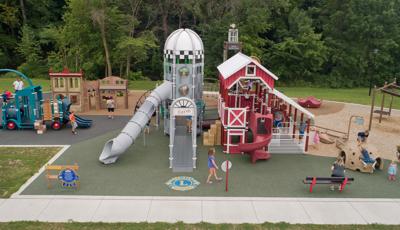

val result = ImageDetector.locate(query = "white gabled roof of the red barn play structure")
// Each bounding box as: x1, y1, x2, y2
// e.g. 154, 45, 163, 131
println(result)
217, 52, 278, 80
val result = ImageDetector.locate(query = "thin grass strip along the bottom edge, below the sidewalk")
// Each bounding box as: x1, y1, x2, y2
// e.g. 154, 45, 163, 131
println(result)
0, 221, 399, 230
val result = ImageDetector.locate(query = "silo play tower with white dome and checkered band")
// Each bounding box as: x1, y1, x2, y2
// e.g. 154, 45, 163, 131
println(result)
163, 29, 204, 172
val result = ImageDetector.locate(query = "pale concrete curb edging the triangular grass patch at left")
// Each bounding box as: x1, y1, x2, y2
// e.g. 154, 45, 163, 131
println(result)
6, 145, 70, 198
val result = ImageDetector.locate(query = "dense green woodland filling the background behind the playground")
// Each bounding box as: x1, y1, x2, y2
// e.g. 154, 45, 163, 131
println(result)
0, 0, 400, 87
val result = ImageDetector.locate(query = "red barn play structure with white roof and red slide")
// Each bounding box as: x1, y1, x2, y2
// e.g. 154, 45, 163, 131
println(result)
218, 52, 314, 158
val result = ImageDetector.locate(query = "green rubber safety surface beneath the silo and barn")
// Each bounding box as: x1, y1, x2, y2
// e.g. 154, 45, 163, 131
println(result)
22, 128, 400, 198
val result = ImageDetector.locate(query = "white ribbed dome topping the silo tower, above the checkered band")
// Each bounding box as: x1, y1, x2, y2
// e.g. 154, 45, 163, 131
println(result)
164, 29, 204, 51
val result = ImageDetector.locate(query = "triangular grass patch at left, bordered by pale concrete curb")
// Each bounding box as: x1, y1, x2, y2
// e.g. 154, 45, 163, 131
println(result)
0, 147, 60, 198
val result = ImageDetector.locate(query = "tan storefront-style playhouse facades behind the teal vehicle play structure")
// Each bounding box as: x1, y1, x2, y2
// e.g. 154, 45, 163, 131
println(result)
49, 68, 128, 112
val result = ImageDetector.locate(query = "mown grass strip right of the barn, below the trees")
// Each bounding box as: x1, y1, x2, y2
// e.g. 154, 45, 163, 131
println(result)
277, 87, 400, 109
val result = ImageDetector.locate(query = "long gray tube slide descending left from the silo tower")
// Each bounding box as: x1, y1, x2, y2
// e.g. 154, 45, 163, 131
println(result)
99, 81, 172, 164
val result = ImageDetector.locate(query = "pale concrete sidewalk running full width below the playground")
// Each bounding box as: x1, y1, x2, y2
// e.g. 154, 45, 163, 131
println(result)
0, 196, 400, 224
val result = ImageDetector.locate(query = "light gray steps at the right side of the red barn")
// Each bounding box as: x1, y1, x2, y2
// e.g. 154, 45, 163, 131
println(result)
268, 135, 304, 154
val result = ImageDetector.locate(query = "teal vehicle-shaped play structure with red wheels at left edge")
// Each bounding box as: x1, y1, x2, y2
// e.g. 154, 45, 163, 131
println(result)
0, 69, 92, 130
